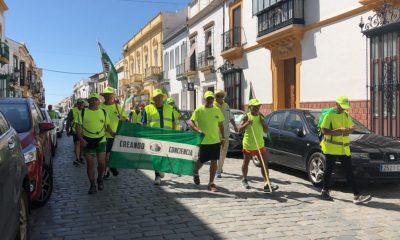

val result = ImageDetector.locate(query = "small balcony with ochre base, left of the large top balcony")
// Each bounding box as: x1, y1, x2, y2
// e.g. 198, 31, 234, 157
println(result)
221, 27, 246, 61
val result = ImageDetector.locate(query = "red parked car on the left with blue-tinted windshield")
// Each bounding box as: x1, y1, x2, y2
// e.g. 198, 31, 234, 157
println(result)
0, 98, 54, 206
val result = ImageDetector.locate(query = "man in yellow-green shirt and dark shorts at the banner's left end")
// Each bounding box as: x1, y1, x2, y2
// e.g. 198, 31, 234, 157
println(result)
74, 93, 115, 194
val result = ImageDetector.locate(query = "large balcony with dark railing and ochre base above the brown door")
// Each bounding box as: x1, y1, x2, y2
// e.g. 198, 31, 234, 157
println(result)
257, 0, 304, 49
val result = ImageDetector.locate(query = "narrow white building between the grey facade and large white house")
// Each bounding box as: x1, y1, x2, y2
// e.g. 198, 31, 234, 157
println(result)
182, 0, 224, 110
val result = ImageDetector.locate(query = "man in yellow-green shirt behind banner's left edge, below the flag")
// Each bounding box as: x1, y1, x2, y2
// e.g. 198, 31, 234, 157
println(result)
100, 87, 128, 179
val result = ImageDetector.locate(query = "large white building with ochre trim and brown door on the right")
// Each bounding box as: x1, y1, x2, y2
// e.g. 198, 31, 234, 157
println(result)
220, 0, 400, 137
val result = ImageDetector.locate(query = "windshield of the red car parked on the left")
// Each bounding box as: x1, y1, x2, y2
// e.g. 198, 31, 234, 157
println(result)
0, 103, 31, 133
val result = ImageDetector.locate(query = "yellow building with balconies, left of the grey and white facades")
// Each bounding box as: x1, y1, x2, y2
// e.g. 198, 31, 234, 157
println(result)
120, 11, 186, 103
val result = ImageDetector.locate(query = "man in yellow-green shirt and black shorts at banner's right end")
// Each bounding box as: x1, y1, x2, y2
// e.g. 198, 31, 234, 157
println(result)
189, 91, 224, 192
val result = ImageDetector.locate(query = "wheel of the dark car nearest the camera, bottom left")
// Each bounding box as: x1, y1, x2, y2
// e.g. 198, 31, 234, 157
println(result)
15, 189, 29, 240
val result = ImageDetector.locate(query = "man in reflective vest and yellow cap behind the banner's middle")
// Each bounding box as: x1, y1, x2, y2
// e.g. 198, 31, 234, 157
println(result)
142, 88, 176, 185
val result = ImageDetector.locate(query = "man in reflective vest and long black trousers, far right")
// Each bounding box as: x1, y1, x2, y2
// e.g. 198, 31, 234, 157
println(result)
321, 96, 371, 204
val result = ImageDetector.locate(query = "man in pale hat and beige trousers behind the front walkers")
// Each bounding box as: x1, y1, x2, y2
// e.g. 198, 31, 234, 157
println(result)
214, 90, 238, 178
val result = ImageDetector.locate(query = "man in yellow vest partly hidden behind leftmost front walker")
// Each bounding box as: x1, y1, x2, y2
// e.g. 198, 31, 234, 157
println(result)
66, 98, 85, 166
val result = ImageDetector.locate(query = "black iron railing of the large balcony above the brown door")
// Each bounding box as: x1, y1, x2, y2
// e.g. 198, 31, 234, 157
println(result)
257, 0, 304, 37
